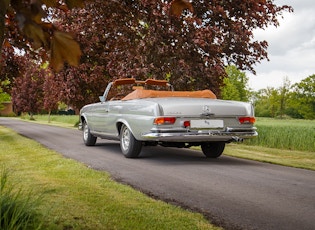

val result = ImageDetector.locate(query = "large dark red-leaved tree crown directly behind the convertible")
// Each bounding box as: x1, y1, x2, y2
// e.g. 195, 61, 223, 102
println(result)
50, 0, 291, 97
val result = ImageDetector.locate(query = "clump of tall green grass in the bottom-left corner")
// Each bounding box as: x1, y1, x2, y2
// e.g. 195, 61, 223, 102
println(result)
0, 167, 41, 230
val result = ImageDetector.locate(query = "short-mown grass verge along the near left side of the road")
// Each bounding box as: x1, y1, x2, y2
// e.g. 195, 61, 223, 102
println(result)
0, 126, 218, 230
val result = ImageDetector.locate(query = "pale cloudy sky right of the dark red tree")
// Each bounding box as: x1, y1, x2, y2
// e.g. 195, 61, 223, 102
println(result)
246, 0, 315, 91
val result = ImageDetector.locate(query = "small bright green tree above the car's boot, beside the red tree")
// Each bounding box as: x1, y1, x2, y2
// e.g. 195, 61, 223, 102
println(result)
221, 66, 250, 101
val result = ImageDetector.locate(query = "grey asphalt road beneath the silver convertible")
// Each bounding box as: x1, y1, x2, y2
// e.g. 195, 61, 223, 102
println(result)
0, 118, 315, 230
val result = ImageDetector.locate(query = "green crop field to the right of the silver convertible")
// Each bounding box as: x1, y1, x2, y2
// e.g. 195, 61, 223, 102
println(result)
244, 118, 315, 152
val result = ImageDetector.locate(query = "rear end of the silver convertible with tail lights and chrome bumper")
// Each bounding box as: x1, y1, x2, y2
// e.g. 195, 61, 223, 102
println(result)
142, 98, 258, 143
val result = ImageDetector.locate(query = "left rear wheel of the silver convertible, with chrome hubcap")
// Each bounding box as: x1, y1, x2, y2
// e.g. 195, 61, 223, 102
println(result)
120, 125, 142, 158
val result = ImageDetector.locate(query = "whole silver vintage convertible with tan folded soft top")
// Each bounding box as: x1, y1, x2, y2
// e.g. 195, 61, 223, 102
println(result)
79, 78, 258, 158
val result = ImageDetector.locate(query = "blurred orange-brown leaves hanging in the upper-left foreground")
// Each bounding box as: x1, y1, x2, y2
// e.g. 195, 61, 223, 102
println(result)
0, 0, 87, 70
